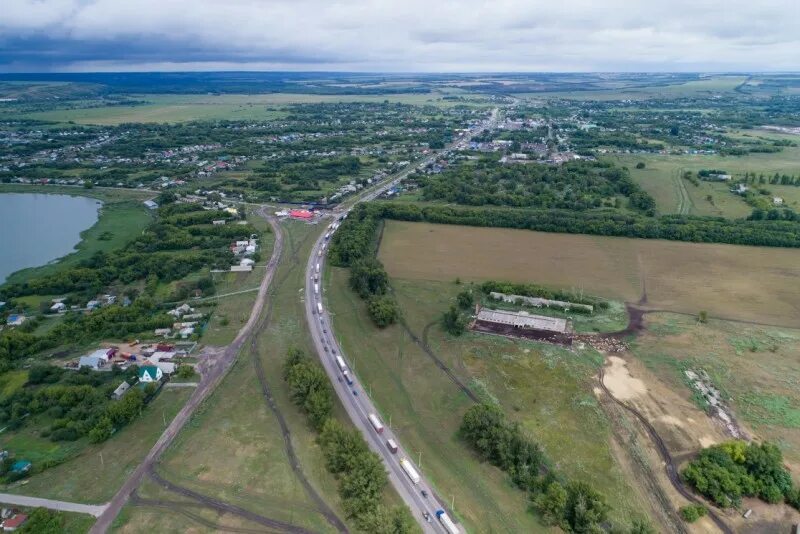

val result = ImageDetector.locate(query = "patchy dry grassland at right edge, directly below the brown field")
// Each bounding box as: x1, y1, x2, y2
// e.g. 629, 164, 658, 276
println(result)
631, 313, 800, 465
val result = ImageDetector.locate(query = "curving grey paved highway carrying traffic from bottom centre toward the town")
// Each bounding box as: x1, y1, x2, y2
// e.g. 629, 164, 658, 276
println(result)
305, 109, 497, 533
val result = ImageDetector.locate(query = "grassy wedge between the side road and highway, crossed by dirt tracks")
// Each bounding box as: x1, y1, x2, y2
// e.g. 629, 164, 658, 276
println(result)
137, 222, 372, 532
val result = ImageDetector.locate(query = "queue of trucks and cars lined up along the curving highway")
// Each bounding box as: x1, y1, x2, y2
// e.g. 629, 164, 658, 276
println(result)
312, 215, 461, 534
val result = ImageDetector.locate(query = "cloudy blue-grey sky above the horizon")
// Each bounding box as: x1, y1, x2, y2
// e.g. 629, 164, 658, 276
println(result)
0, 0, 800, 72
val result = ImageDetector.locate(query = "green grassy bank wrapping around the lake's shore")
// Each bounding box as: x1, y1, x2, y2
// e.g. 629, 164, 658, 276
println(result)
0, 186, 152, 283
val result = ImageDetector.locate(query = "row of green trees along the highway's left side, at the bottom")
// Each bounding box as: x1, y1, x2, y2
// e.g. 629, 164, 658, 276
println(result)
284, 349, 414, 534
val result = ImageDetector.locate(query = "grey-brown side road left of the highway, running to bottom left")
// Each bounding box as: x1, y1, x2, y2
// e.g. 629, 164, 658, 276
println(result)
89, 208, 283, 534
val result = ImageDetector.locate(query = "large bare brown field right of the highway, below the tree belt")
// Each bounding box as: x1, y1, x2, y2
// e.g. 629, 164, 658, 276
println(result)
379, 221, 800, 327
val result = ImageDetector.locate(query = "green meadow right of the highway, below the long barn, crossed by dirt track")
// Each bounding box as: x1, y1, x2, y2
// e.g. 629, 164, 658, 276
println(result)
326, 268, 645, 532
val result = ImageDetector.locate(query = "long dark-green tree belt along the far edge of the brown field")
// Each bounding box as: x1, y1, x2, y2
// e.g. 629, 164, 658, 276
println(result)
350, 202, 800, 250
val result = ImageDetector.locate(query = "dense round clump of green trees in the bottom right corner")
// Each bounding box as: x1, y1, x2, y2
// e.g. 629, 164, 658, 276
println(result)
681, 441, 800, 509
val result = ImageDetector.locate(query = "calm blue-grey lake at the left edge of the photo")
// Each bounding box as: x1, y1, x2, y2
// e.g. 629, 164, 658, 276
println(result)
0, 193, 102, 283
